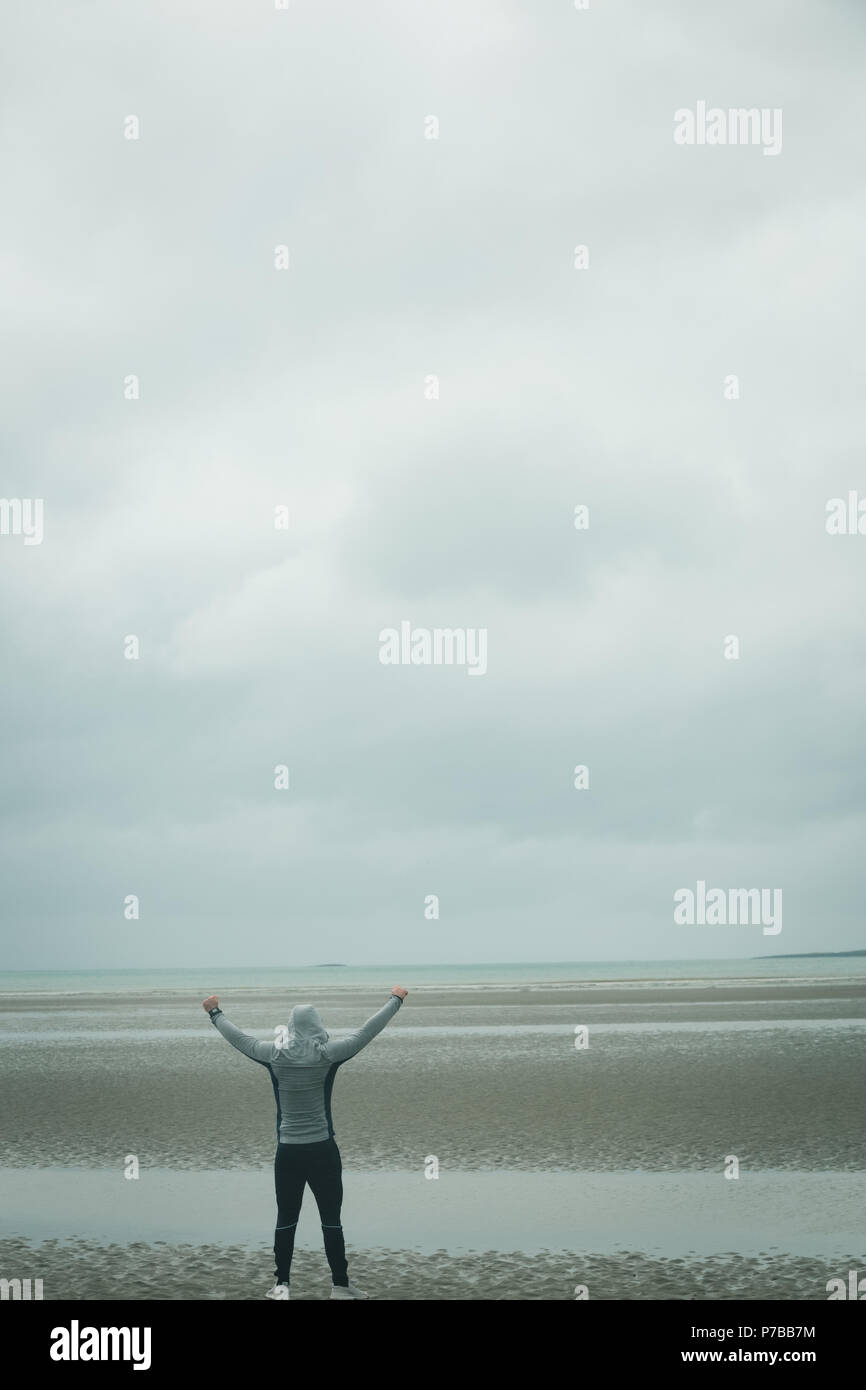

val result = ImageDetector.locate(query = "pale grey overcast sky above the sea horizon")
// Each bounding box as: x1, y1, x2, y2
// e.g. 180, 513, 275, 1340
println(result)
0, 0, 866, 969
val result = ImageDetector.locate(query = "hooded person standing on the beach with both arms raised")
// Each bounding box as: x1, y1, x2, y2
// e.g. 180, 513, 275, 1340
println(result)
202, 986, 409, 1298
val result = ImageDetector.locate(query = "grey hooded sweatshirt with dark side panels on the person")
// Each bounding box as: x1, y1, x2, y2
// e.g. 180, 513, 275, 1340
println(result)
210, 994, 403, 1144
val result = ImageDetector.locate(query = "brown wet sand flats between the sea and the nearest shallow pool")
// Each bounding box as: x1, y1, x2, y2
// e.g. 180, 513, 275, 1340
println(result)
0, 981, 866, 1172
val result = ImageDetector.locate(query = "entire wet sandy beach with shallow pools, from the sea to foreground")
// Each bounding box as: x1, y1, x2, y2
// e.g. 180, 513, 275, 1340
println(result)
0, 977, 866, 1300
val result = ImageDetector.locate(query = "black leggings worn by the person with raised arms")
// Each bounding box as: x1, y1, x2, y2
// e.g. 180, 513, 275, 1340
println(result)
274, 1138, 349, 1289
